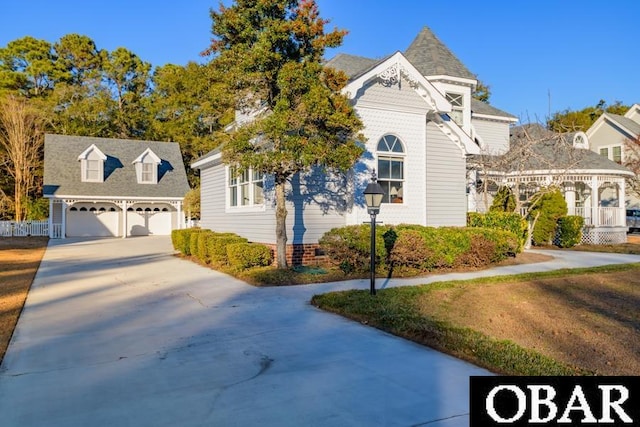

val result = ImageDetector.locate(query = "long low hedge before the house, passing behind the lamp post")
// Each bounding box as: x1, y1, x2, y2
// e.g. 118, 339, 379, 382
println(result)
320, 224, 522, 273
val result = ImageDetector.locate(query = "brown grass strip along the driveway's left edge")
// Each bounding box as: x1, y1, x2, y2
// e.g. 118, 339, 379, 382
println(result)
0, 237, 48, 363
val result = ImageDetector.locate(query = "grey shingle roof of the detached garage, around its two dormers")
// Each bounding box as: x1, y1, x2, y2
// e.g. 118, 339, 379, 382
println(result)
44, 135, 189, 198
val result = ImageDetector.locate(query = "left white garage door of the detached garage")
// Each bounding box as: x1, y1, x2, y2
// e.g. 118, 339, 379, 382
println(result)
66, 205, 120, 237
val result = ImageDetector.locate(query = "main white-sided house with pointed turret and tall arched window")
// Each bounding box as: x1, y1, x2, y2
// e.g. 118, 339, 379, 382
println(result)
192, 27, 517, 263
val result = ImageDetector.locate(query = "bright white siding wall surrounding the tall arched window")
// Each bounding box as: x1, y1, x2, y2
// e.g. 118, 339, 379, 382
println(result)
347, 103, 426, 224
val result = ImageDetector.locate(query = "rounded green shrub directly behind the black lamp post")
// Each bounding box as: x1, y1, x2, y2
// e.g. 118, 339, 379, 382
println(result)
319, 224, 389, 274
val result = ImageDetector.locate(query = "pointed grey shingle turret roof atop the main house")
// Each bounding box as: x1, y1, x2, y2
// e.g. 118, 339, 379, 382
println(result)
404, 27, 476, 80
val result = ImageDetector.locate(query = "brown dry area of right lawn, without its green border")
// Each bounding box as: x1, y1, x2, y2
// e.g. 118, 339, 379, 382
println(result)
418, 267, 640, 375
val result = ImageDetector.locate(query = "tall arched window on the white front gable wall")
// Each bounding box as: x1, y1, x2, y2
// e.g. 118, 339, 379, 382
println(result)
377, 135, 405, 203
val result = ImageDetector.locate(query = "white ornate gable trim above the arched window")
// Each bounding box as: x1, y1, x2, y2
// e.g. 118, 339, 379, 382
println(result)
343, 52, 451, 112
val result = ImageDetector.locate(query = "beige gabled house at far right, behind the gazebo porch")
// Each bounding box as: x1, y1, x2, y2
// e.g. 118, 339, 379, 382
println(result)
586, 104, 640, 209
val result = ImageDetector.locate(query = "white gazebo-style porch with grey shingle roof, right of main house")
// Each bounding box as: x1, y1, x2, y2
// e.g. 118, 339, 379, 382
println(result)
470, 124, 633, 244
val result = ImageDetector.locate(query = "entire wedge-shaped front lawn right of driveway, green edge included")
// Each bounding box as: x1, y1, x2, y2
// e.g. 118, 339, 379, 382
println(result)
312, 264, 640, 375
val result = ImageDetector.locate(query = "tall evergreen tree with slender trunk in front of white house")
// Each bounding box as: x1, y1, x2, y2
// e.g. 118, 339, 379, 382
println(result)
208, 0, 363, 268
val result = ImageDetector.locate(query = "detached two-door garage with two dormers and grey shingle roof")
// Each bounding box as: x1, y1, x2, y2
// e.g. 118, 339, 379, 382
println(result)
43, 135, 189, 238
